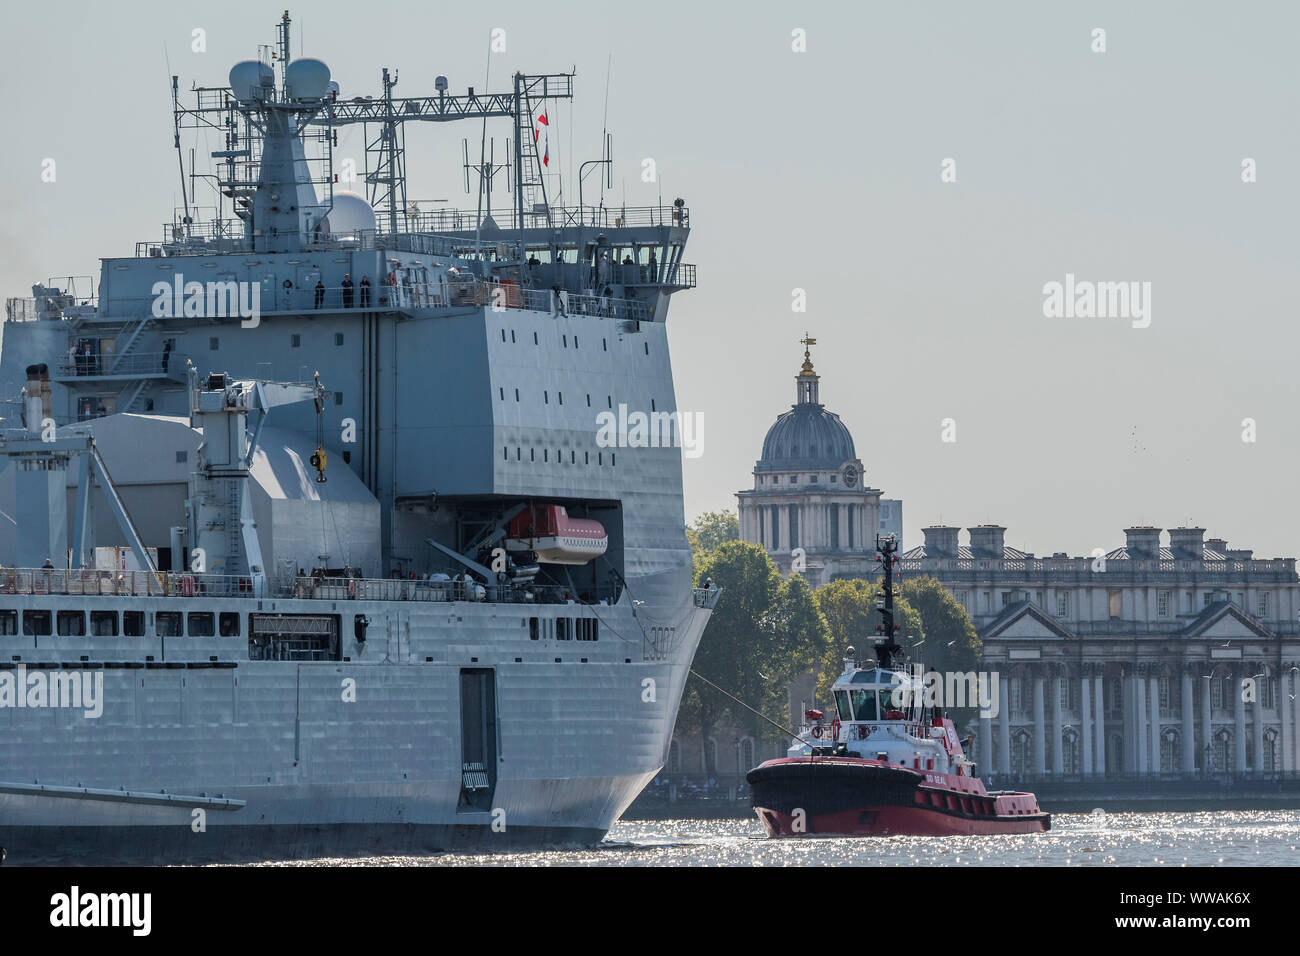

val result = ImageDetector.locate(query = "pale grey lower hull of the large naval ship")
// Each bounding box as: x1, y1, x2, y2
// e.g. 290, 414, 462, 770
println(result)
0, 594, 709, 865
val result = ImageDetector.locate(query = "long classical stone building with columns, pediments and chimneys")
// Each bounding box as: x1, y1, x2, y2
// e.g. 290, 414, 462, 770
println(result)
901, 525, 1300, 778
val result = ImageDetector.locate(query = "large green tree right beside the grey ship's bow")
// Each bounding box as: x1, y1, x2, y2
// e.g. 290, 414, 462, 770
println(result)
677, 541, 826, 774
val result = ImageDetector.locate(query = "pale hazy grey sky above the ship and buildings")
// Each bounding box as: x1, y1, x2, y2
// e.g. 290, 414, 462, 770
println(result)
0, 0, 1300, 557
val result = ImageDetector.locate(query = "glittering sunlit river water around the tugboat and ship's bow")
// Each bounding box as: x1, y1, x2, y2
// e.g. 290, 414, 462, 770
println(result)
271, 810, 1300, 866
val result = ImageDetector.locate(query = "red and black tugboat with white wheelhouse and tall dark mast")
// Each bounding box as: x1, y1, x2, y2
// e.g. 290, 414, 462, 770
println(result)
746, 536, 1052, 836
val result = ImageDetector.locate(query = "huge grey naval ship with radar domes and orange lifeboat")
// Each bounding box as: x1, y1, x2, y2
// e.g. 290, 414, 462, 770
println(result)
0, 13, 718, 862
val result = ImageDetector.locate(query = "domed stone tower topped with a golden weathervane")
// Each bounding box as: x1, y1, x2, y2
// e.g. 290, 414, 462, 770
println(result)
736, 336, 902, 588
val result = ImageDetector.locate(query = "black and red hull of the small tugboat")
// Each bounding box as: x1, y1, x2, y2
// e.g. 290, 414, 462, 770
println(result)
748, 758, 1052, 836
